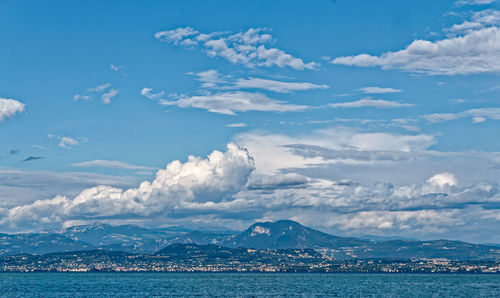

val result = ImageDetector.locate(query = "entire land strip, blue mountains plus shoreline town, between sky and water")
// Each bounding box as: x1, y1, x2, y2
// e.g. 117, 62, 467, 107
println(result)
0, 220, 500, 273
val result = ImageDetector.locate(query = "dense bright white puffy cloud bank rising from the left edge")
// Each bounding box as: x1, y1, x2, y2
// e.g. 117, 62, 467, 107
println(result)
0, 144, 254, 229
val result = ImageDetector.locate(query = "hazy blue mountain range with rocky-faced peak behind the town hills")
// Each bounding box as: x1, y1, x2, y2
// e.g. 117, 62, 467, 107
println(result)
0, 220, 500, 260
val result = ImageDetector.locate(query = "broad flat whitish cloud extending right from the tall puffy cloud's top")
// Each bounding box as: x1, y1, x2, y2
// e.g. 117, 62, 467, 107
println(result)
235, 127, 436, 173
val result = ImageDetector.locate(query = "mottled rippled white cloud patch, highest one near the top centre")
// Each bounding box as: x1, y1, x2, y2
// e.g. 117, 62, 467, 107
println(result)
155, 27, 318, 70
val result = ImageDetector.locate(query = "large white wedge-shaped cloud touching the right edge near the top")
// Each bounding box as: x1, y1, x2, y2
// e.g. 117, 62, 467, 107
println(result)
332, 27, 500, 75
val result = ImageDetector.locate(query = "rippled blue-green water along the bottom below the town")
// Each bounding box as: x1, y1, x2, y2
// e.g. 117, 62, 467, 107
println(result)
0, 273, 500, 297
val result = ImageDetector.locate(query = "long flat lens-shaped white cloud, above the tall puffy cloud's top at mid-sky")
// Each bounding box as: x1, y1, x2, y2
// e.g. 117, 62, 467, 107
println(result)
160, 91, 307, 115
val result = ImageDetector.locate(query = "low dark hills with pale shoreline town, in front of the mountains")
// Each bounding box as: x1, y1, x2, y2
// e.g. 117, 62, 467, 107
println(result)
0, 244, 500, 274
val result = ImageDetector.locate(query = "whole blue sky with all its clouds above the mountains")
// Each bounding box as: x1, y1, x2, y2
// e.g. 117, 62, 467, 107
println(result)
0, 0, 500, 243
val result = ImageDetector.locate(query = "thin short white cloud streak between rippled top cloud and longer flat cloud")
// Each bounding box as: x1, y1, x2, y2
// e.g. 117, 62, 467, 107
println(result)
233, 78, 330, 93
